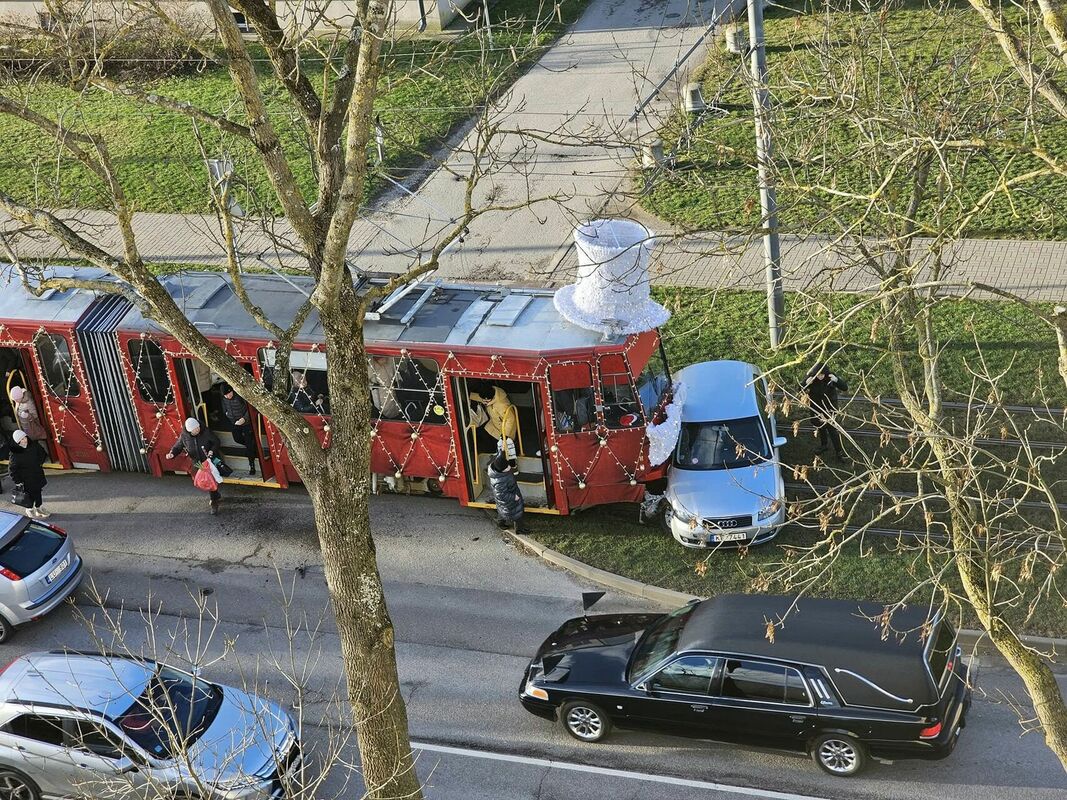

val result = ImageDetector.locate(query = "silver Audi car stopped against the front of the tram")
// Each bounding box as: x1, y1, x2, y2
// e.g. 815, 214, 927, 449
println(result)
663, 361, 785, 547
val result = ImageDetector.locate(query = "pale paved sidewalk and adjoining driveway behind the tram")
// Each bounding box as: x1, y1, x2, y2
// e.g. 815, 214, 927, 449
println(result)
0, 0, 1067, 302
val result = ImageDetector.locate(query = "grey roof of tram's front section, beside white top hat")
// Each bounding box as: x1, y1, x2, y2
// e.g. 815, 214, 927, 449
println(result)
118, 272, 625, 352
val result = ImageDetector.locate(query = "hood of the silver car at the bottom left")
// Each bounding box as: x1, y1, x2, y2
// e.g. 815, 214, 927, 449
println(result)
190, 686, 296, 783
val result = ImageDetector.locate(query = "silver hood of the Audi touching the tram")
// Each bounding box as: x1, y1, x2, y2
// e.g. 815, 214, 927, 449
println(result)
667, 462, 781, 517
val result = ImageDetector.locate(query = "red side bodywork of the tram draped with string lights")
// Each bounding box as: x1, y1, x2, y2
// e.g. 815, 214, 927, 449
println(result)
0, 263, 663, 510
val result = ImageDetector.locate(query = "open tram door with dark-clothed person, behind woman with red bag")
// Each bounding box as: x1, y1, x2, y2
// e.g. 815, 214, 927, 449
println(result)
174, 358, 274, 483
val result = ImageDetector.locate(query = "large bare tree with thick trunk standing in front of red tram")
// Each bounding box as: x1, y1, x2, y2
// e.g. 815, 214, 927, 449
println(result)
0, 0, 567, 798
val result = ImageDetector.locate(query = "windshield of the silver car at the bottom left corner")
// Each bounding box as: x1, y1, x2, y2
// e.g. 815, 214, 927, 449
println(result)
116, 666, 222, 758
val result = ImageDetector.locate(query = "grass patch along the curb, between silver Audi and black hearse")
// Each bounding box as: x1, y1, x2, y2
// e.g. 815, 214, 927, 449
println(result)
527, 506, 1067, 636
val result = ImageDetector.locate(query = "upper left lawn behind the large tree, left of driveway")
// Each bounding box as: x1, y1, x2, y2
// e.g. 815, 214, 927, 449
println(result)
0, 0, 588, 212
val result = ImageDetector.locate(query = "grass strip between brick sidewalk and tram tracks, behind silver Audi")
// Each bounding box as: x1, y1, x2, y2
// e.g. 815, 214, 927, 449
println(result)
653, 287, 1067, 407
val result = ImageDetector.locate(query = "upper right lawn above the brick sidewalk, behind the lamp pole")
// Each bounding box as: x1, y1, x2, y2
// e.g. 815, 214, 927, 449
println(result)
643, 0, 1067, 239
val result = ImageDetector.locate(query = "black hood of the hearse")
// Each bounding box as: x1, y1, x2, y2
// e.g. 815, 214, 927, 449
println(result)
535, 614, 663, 684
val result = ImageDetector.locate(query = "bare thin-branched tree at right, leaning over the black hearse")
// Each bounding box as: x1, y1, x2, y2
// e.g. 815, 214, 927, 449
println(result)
665, 4, 1067, 767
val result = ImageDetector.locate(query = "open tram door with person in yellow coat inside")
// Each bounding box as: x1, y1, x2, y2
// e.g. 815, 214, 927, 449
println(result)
452, 378, 555, 511
